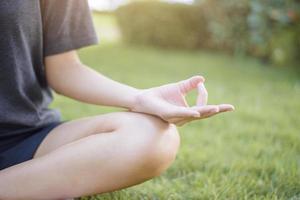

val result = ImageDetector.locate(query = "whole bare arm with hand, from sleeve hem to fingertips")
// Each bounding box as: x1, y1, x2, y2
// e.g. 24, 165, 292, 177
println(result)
45, 51, 234, 125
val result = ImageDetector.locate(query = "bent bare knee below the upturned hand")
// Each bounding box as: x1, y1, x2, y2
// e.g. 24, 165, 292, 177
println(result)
117, 113, 180, 176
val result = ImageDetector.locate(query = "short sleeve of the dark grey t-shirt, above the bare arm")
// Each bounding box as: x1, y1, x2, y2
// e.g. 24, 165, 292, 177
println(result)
41, 0, 98, 56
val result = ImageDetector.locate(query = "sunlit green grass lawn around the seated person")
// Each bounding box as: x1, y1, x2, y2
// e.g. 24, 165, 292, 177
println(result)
52, 13, 300, 200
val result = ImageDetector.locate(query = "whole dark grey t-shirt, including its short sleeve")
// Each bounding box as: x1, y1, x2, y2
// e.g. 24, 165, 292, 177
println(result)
0, 0, 97, 152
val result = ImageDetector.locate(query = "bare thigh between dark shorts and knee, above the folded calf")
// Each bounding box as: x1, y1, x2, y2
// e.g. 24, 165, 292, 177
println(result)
34, 112, 128, 158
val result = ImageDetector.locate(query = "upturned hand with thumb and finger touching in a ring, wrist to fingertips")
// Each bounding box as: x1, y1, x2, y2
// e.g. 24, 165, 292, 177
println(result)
131, 76, 234, 126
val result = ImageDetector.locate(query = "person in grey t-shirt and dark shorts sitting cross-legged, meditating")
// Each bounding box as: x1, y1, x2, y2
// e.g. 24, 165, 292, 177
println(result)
0, 0, 233, 200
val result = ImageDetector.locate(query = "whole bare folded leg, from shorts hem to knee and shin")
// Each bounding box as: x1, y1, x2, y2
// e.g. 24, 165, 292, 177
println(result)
0, 113, 179, 200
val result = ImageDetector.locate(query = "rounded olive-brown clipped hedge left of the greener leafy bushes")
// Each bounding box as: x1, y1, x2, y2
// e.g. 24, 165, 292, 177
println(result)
117, 2, 208, 48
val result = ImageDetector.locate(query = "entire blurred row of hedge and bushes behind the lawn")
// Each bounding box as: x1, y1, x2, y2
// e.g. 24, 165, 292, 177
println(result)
116, 0, 300, 66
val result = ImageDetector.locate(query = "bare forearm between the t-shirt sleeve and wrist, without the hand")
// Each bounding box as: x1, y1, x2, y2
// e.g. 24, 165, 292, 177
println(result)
47, 63, 139, 109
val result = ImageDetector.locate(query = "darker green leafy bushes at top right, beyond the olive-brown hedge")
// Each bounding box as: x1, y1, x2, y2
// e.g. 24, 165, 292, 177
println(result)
195, 0, 300, 65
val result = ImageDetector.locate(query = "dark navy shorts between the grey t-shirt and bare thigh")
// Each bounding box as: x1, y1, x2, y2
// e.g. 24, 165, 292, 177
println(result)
0, 122, 63, 170
